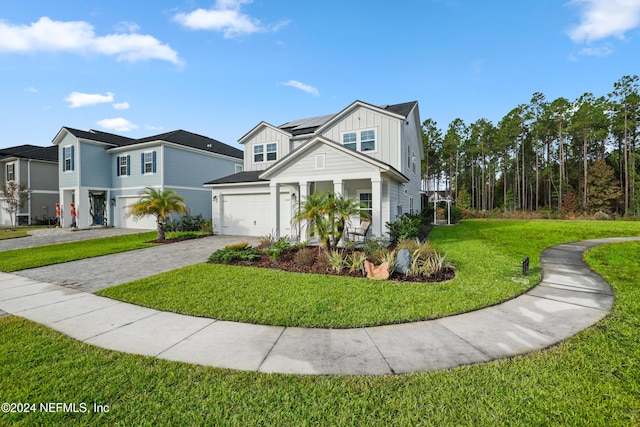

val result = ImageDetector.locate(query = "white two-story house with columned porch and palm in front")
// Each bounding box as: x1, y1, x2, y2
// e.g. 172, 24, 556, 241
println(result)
205, 101, 423, 239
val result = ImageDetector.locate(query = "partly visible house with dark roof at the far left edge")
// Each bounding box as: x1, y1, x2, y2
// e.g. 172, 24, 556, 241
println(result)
0, 145, 58, 225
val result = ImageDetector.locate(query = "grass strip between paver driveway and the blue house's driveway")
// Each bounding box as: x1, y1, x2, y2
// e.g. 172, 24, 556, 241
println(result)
0, 232, 156, 272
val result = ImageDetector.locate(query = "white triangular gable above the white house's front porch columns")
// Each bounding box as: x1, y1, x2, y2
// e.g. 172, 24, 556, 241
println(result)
277, 144, 376, 181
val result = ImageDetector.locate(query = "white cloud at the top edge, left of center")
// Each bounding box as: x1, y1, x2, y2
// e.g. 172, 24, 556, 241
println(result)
173, 0, 288, 38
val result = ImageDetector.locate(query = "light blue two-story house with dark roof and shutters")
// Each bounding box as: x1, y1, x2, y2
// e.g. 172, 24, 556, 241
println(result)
53, 127, 243, 229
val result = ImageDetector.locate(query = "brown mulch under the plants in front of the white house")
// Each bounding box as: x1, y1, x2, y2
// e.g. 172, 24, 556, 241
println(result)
216, 247, 456, 283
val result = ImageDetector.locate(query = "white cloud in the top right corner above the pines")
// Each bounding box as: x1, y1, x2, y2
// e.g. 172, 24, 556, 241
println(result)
567, 0, 640, 43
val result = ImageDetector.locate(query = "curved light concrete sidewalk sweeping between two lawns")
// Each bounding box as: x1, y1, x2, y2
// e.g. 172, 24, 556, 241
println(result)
0, 237, 640, 375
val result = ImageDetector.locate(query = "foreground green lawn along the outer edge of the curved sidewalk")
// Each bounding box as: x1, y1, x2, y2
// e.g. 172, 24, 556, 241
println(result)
0, 242, 640, 427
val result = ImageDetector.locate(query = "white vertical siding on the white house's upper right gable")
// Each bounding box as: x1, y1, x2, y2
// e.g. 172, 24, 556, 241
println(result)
322, 107, 402, 169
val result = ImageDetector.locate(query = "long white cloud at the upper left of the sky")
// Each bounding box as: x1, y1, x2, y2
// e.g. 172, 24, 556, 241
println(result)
0, 16, 181, 64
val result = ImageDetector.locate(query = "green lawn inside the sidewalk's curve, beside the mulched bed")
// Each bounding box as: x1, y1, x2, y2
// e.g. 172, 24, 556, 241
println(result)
99, 220, 640, 328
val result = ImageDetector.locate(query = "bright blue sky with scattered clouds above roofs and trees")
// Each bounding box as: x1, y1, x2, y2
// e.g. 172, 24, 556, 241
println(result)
0, 0, 640, 147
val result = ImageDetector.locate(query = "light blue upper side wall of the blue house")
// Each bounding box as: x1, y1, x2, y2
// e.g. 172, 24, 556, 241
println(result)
164, 146, 242, 188
